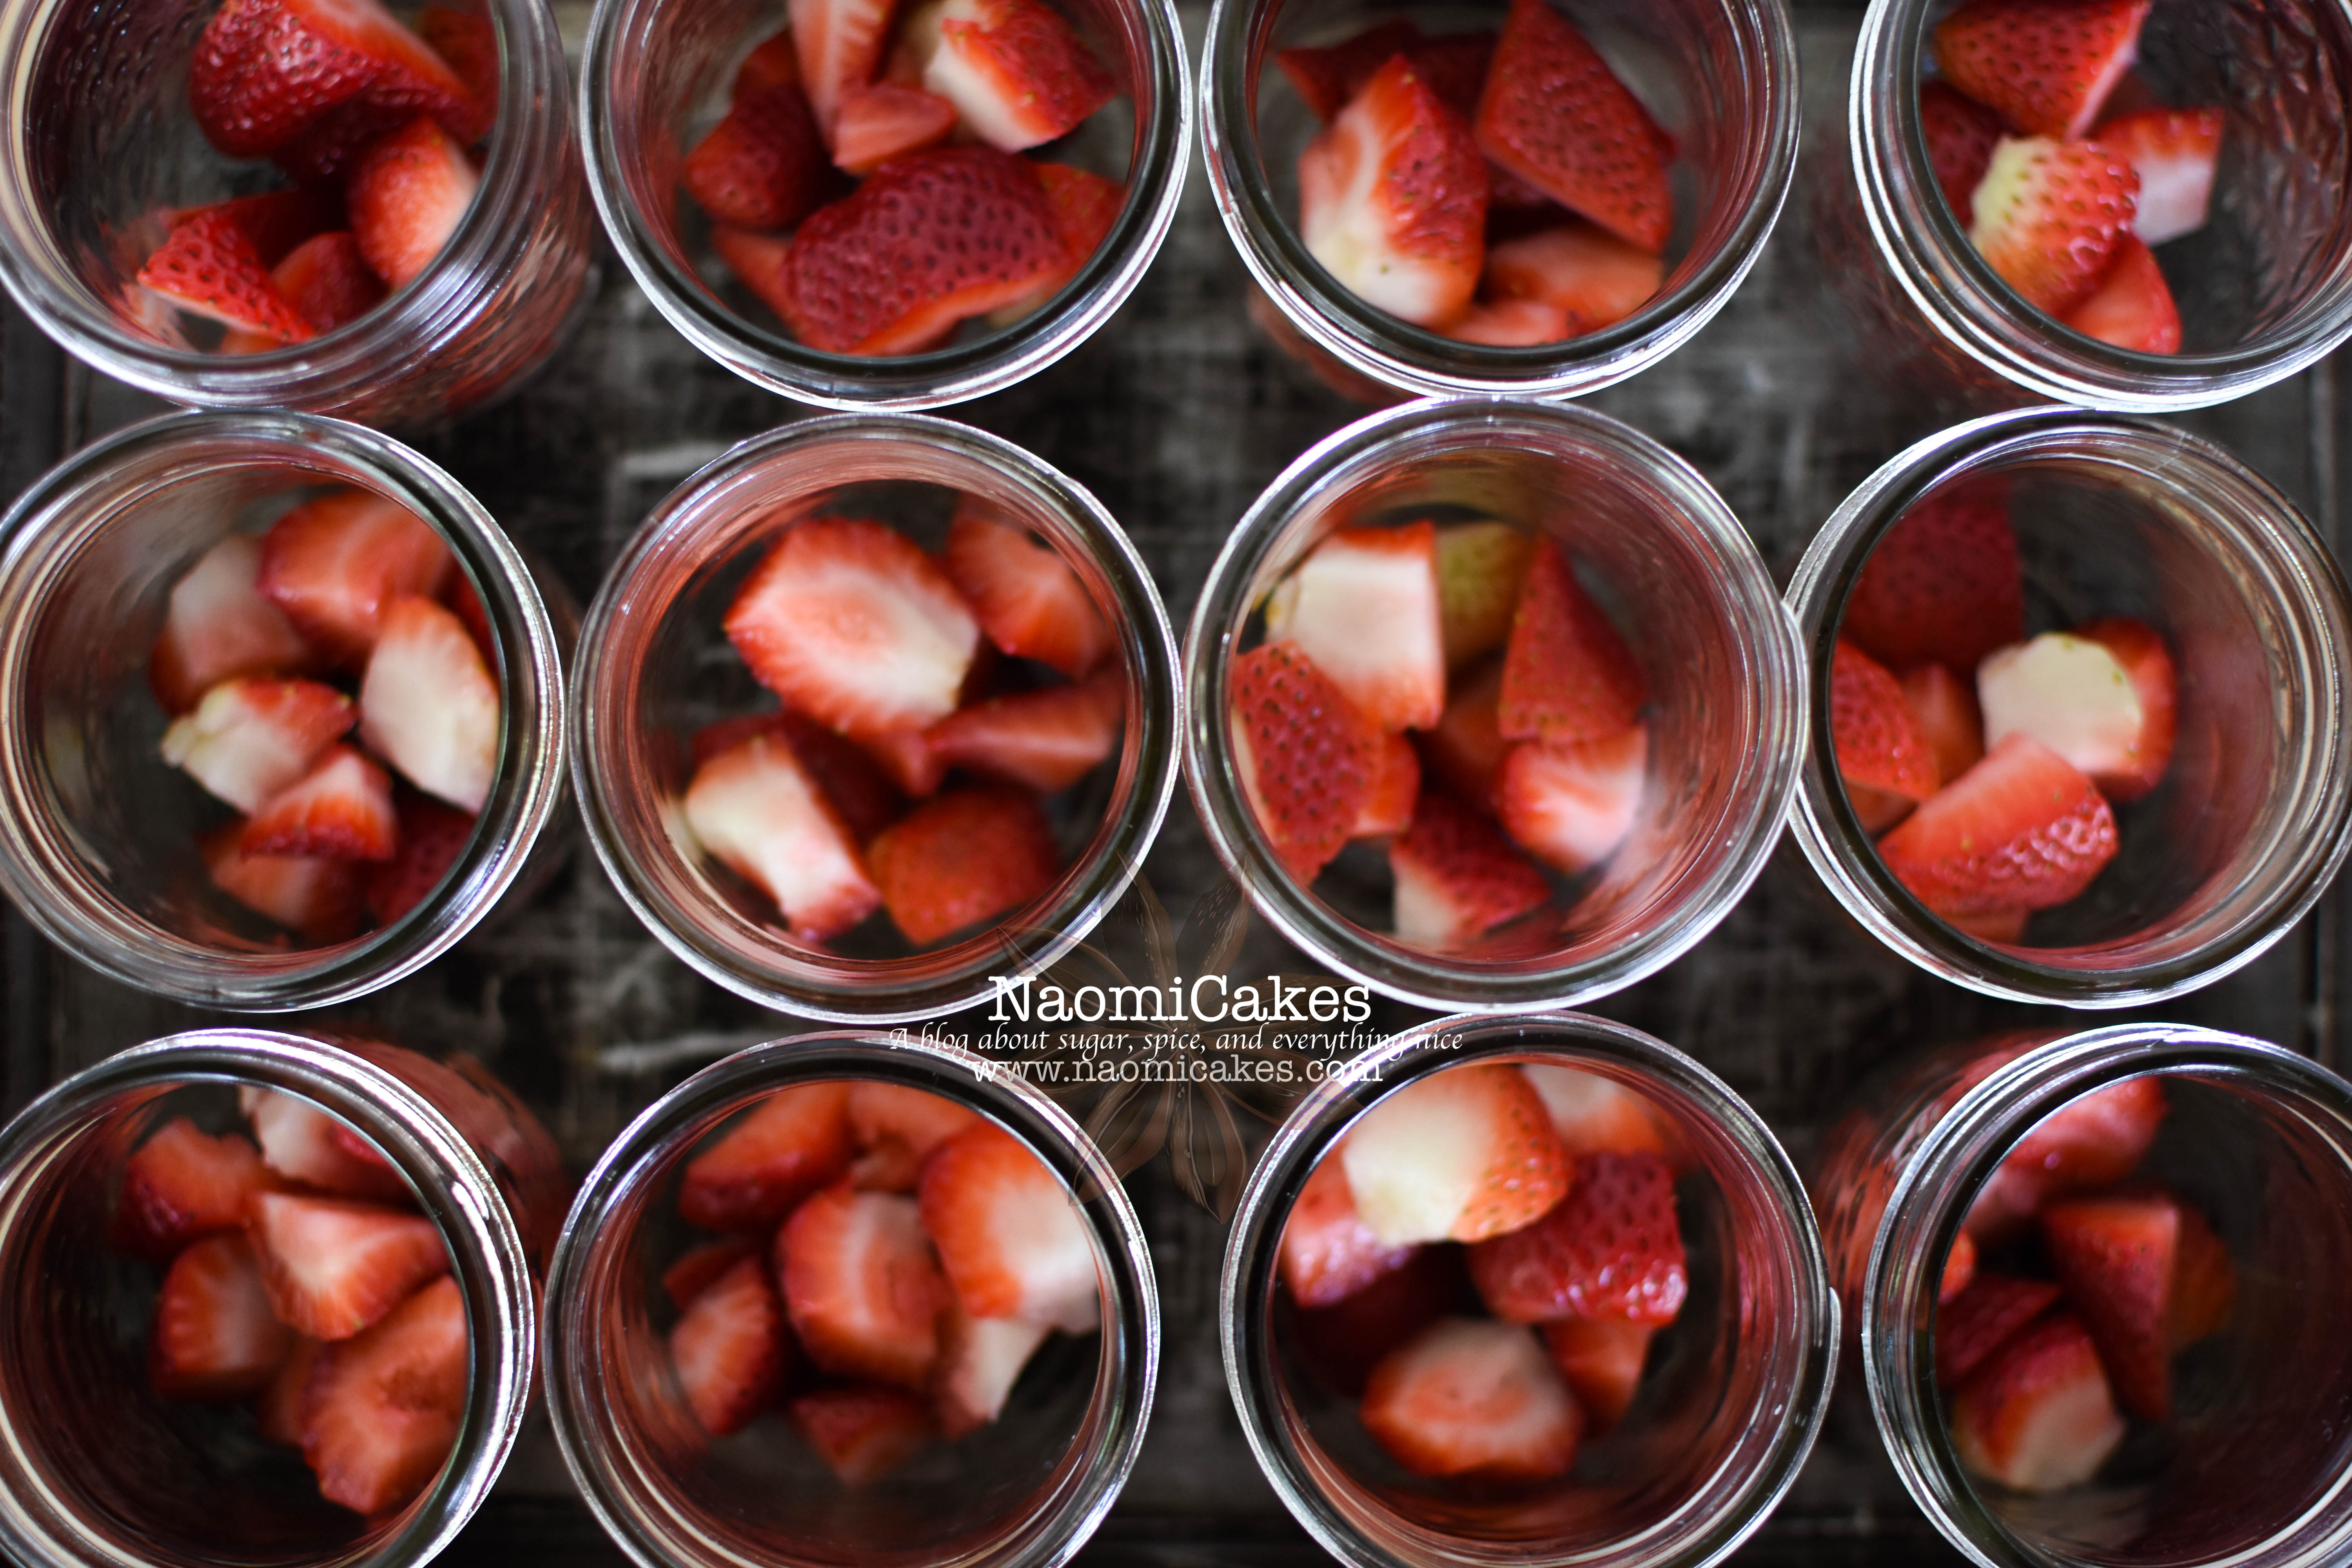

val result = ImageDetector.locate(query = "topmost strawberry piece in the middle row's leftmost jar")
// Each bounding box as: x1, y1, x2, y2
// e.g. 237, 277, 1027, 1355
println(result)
256, 489, 454, 663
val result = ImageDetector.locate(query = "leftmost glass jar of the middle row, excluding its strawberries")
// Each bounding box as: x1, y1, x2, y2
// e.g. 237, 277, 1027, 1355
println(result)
0, 414, 564, 1011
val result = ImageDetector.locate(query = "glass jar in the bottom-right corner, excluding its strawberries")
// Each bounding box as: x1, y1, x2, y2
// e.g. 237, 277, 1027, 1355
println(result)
1813, 1023, 2352, 1568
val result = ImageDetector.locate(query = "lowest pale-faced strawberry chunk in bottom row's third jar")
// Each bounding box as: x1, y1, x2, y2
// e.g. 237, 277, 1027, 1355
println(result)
1357, 1316, 1585, 1481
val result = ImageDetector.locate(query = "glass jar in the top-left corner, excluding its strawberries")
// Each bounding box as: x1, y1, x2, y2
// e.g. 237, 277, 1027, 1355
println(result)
0, 0, 595, 425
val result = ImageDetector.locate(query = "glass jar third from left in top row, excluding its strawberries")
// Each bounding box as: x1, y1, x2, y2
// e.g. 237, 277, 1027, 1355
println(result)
1200, 0, 1797, 397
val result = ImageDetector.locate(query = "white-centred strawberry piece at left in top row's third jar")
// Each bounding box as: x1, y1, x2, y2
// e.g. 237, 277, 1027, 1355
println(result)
1298, 54, 1486, 327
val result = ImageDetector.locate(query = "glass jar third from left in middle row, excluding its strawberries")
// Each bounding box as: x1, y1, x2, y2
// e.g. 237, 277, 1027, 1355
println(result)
1185, 399, 1806, 1011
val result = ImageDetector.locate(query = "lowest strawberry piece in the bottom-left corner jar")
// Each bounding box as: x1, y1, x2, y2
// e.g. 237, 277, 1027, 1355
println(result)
301, 1279, 473, 1516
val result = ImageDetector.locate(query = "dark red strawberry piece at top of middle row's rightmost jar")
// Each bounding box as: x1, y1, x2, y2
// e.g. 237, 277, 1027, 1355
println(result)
1837, 484, 2025, 670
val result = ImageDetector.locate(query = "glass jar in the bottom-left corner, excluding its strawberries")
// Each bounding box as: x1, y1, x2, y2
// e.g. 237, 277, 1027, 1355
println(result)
0, 1030, 564, 1568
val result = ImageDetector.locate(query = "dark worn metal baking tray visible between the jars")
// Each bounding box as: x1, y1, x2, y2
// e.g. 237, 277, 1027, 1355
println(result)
0, 0, 2345, 1568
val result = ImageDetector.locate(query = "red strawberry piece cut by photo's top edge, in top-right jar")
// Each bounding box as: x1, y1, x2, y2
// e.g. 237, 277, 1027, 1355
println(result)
1936, 0, 2150, 139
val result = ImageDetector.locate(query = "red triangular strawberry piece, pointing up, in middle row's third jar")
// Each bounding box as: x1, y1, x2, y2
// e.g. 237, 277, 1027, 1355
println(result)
1496, 538, 1649, 743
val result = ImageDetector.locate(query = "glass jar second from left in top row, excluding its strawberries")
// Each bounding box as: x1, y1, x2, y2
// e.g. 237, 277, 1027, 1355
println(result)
579, 0, 1192, 409
